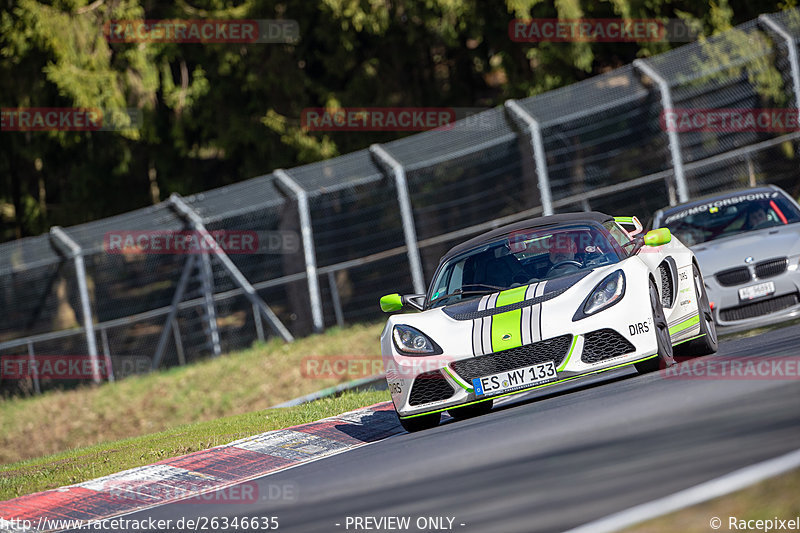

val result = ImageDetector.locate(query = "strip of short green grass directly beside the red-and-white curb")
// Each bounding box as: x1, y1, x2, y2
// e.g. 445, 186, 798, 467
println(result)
0, 391, 390, 500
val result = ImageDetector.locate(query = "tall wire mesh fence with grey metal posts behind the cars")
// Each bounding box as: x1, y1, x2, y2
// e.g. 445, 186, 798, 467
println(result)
0, 9, 800, 393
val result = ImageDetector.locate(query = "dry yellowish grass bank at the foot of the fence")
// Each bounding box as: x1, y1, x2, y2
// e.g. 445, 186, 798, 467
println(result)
0, 324, 382, 464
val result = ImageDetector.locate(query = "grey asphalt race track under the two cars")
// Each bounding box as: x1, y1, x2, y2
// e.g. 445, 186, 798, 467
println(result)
87, 326, 800, 533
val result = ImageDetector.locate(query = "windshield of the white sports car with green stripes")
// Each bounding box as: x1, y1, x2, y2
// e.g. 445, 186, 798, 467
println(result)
428, 223, 624, 307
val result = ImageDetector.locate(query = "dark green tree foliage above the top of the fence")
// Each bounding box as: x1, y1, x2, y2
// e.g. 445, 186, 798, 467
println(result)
0, 0, 793, 240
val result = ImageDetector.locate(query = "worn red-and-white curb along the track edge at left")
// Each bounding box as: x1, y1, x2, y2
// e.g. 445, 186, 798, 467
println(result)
0, 402, 412, 532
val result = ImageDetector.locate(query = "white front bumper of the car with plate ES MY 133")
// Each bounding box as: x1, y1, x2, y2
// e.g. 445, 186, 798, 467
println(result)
381, 286, 657, 417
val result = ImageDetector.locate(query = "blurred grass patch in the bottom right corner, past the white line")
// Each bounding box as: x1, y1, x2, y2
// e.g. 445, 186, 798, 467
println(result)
623, 470, 800, 533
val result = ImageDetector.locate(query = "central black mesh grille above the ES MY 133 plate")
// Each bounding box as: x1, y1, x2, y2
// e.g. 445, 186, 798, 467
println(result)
451, 335, 572, 383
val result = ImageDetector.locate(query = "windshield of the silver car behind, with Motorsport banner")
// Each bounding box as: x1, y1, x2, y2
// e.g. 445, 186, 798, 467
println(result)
661, 192, 800, 246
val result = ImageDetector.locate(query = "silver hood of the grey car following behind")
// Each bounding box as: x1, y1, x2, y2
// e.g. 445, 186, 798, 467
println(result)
691, 224, 800, 276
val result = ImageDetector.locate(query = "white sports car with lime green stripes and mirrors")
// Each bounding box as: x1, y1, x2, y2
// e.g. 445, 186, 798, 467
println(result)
381, 212, 717, 431
